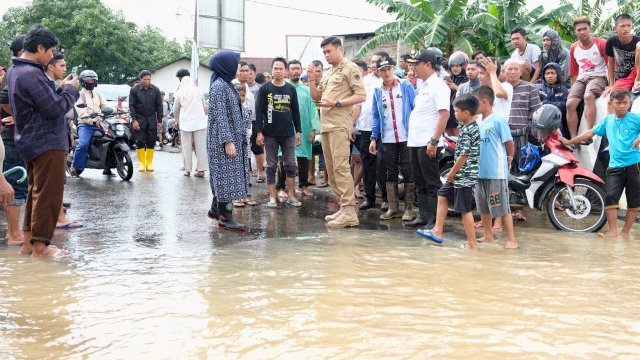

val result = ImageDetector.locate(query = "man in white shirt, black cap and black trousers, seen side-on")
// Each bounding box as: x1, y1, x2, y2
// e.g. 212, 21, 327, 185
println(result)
407, 50, 451, 229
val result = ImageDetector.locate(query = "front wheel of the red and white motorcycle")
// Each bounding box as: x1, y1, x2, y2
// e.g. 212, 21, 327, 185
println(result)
547, 179, 607, 232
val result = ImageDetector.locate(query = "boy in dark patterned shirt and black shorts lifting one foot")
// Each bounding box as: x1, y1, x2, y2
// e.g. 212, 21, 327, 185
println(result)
418, 94, 480, 249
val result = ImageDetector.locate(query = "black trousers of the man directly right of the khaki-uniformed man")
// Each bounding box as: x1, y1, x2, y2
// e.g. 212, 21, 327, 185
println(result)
359, 131, 387, 202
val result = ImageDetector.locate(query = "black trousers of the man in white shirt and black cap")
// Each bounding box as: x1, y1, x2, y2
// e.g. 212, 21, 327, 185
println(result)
409, 146, 442, 197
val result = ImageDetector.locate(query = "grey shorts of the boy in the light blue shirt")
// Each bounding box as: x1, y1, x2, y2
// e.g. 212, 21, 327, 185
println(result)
476, 179, 511, 218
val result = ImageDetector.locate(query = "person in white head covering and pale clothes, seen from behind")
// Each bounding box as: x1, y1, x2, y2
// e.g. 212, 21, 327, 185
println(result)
173, 76, 207, 177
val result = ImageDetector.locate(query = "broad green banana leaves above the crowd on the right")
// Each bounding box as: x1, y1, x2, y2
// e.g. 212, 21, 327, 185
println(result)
358, 0, 640, 57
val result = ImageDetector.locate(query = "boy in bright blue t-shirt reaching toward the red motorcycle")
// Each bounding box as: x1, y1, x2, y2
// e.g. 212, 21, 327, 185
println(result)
560, 89, 640, 237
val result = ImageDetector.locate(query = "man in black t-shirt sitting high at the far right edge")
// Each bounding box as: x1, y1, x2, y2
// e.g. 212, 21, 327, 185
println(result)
602, 14, 640, 97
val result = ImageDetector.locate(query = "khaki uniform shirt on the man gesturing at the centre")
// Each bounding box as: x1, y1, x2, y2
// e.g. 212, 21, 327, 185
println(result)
318, 59, 367, 133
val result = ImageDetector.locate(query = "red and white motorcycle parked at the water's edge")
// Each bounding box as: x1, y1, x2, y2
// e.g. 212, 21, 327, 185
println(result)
509, 129, 607, 232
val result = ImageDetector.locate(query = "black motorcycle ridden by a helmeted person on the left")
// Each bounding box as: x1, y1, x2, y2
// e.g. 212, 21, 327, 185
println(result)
66, 104, 133, 181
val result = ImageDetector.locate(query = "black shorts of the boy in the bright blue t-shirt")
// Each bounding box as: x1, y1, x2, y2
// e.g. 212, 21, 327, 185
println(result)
604, 164, 640, 211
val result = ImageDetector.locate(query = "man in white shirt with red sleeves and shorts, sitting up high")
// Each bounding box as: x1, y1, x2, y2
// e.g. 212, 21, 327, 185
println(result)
567, 16, 609, 138
